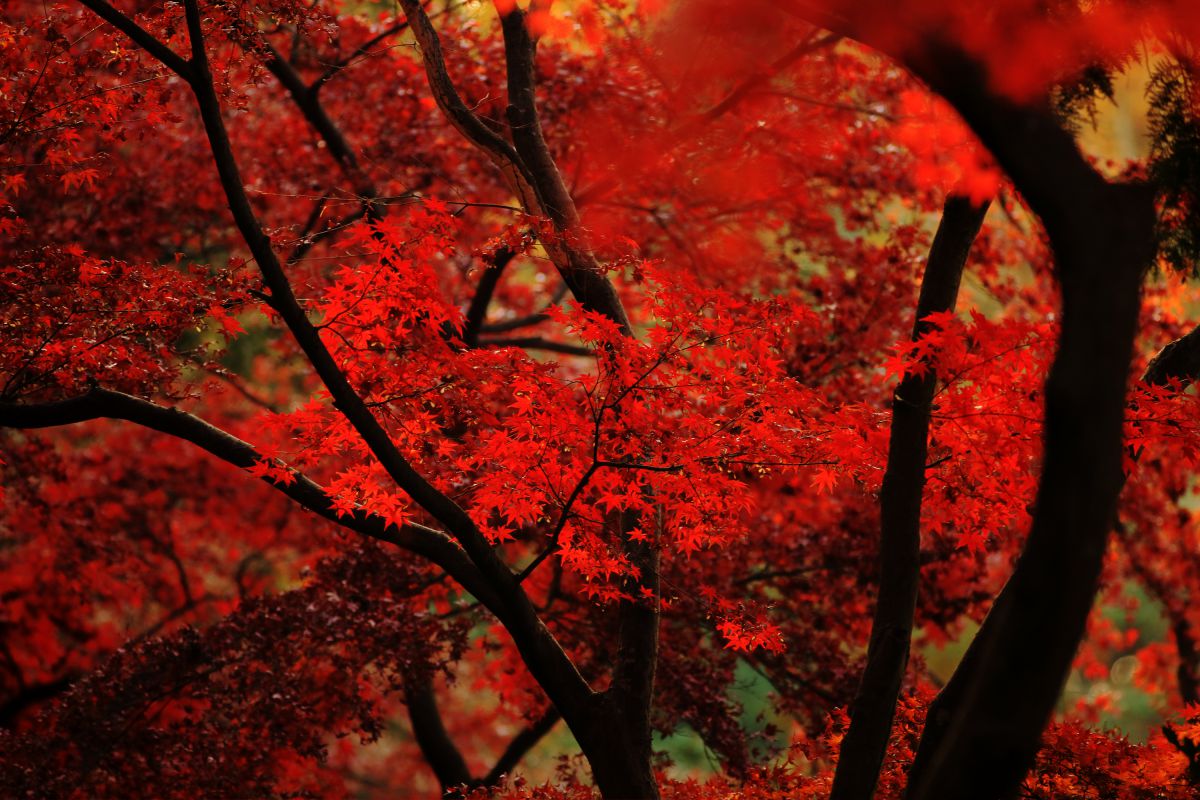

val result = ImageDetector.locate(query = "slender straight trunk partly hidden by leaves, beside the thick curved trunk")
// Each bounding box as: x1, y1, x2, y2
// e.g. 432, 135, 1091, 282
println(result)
830, 194, 988, 800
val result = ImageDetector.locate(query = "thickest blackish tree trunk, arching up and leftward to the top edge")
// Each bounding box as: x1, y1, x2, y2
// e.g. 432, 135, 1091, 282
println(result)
758, 0, 1154, 800
